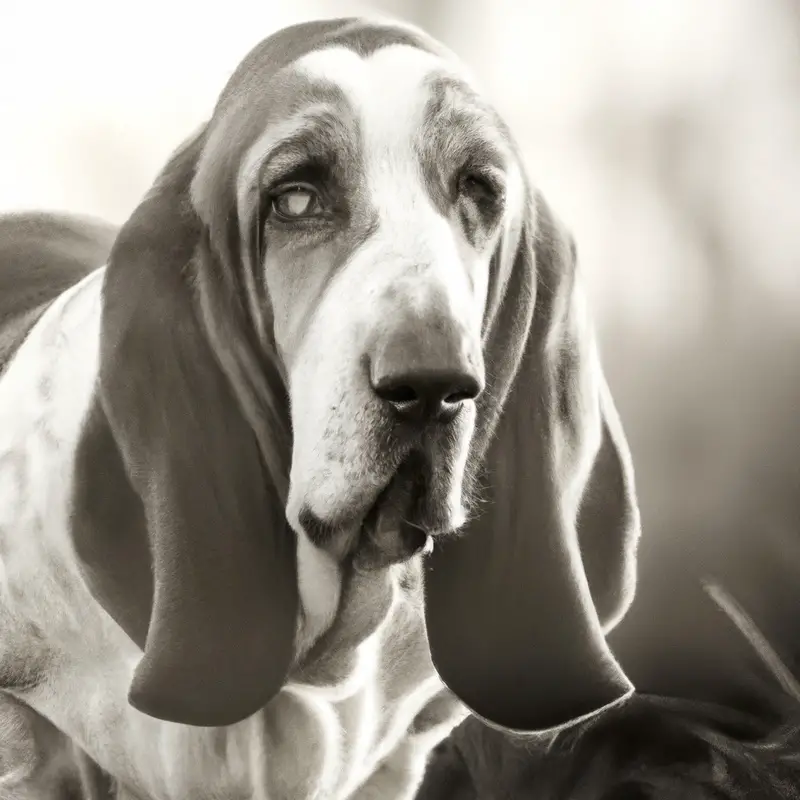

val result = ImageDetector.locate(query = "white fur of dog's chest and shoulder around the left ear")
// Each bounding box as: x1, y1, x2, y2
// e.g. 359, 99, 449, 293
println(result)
0, 270, 463, 800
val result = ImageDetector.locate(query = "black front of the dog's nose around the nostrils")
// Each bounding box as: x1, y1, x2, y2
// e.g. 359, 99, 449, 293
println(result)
372, 368, 481, 422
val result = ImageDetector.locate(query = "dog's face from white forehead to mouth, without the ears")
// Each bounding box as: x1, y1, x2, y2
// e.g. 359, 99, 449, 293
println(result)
196, 36, 522, 556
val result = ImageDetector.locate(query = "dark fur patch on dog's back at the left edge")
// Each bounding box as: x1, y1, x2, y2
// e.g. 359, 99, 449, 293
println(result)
0, 212, 116, 373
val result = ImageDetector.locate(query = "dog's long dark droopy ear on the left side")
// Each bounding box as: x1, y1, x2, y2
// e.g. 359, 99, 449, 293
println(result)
74, 133, 298, 725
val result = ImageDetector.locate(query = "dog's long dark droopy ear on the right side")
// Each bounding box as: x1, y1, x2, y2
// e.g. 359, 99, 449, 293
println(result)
425, 188, 639, 731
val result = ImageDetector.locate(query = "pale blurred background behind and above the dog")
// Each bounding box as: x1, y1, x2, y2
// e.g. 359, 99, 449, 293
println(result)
0, 0, 800, 700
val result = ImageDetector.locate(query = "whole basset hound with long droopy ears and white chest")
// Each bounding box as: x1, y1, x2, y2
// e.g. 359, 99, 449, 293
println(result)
0, 19, 639, 800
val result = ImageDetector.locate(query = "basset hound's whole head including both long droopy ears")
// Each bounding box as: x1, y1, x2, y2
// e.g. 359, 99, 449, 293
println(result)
72, 20, 638, 729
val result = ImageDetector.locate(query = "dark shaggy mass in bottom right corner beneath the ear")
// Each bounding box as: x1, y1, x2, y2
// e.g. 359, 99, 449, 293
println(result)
417, 696, 800, 800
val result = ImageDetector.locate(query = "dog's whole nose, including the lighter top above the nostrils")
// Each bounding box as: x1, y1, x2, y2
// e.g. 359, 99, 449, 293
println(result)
370, 318, 483, 423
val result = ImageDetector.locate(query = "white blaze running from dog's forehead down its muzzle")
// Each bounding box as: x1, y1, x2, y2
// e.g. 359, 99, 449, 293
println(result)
287, 45, 489, 544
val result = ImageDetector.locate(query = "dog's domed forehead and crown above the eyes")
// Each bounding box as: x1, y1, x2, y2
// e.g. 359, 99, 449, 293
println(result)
196, 21, 513, 209
